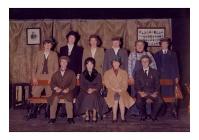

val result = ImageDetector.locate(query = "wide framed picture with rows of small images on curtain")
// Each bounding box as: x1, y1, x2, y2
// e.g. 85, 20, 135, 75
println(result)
137, 27, 165, 47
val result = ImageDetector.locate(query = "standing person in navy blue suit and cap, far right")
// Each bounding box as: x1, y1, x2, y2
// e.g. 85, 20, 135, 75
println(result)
155, 38, 179, 118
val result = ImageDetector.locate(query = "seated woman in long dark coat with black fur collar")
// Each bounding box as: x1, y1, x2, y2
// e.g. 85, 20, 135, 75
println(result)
77, 57, 105, 122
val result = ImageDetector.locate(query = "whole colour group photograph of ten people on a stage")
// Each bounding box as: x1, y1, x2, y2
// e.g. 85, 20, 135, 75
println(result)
9, 8, 190, 132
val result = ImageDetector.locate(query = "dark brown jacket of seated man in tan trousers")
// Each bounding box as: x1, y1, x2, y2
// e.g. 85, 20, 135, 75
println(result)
48, 69, 76, 104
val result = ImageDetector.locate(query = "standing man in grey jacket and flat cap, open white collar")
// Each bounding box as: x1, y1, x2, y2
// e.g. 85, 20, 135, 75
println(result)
103, 37, 128, 72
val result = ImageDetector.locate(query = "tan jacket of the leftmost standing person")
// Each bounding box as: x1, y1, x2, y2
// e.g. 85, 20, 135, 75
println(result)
32, 50, 59, 80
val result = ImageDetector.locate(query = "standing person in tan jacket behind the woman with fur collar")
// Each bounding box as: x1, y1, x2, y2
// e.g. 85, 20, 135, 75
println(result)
82, 35, 104, 74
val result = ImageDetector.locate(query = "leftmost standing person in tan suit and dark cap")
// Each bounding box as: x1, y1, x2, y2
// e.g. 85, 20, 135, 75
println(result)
29, 39, 59, 118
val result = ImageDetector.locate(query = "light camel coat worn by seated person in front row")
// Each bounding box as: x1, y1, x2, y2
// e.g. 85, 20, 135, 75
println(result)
103, 68, 135, 108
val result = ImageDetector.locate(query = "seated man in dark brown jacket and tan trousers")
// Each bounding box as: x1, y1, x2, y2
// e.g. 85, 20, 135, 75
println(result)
48, 56, 76, 124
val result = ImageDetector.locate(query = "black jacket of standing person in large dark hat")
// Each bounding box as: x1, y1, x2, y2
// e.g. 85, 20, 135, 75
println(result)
60, 45, 83, 74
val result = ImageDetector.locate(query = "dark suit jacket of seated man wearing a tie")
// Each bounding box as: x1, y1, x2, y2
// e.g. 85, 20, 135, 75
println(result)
135, 68, 160, 94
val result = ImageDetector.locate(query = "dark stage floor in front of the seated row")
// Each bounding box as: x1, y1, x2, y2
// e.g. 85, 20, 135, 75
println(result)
9, 106, 190, 132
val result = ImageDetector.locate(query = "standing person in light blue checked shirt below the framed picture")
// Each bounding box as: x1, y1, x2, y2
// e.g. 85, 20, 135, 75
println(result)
128, 40, 157, 97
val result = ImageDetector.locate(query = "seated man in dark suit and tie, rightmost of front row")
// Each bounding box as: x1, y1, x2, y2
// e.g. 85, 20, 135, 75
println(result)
135, 55, 163, 121
